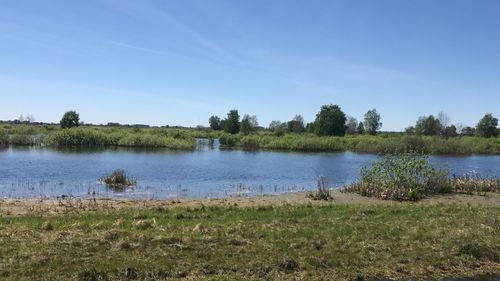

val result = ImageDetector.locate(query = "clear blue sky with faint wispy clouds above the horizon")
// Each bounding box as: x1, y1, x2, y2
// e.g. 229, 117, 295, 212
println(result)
0, 0, 500, 131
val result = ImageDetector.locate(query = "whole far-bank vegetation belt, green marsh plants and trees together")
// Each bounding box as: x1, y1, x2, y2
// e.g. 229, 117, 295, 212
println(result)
0, 105, 500, 155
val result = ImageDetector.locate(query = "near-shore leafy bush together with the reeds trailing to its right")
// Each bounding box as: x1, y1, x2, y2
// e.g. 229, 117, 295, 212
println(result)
344, 154, 500, 201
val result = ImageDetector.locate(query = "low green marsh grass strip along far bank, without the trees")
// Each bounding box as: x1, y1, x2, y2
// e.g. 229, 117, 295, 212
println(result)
4, 122, 500, 155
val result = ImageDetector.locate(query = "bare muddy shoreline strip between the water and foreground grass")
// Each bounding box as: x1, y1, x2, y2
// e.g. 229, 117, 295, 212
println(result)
0, 189, 500, 216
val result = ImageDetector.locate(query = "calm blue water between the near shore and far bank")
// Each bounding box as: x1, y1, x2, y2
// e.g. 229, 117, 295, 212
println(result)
0, 142, 500, 199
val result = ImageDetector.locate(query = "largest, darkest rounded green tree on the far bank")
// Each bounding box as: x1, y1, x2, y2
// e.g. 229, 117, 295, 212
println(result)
314, 105, 346, 136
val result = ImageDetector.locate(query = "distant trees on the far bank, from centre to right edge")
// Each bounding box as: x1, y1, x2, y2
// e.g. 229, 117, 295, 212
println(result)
208, 104, 500, 138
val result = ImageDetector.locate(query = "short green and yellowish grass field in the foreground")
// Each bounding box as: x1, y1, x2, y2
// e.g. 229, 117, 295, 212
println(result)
0, 204, 500, 280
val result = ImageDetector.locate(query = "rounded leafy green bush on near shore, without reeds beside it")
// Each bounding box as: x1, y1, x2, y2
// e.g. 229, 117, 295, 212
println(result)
346, 154, 452, 201
